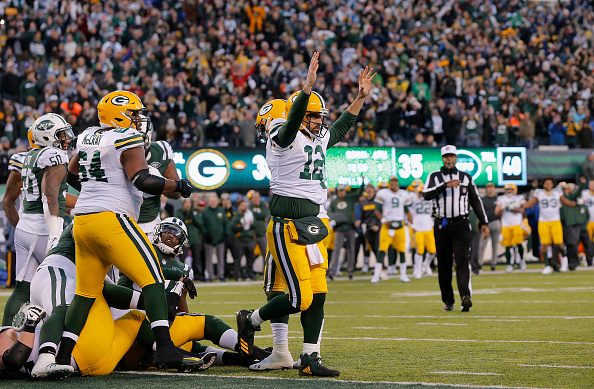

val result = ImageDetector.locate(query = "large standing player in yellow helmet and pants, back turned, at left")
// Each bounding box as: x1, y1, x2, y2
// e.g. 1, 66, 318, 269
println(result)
54, 91, 193, 368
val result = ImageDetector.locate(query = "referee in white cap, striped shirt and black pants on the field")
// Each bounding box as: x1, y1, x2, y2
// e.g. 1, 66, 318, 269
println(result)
423, 145, 489, 312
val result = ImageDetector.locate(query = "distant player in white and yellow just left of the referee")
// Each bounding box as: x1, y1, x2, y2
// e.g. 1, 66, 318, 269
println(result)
410, 178, 435, 279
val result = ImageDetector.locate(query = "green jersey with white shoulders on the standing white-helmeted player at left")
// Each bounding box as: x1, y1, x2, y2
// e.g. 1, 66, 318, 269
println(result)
17, 147, 68, 235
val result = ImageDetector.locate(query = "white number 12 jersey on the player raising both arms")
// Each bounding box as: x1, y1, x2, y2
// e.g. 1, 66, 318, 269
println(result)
266, 119, 330, 205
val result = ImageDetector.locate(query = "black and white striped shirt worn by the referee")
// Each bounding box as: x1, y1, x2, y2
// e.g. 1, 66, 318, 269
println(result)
423, 168, 488, 226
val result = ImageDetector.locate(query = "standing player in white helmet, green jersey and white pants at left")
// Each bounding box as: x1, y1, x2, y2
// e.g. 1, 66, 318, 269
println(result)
2, 113, 74, 325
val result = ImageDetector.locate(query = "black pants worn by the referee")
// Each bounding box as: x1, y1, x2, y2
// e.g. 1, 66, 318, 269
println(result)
433, 219, 472, 304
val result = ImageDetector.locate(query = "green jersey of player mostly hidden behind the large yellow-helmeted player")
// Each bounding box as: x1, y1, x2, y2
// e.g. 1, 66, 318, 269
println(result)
138, 140, 173, 223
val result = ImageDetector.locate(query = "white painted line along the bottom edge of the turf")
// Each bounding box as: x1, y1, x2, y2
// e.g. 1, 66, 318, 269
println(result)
117, 371, 552, 389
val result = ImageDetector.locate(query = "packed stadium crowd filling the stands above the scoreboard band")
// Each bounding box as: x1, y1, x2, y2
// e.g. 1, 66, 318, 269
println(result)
0, 0, 594, 153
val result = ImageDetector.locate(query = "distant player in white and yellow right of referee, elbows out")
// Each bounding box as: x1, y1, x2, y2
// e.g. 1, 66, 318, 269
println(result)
522, 177, 576, 274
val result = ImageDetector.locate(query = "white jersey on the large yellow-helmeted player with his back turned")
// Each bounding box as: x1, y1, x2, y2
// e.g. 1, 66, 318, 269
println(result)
74, 127, 144, 220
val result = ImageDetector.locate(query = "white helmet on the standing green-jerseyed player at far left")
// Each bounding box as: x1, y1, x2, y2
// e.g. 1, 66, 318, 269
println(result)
31, 113, 74, 150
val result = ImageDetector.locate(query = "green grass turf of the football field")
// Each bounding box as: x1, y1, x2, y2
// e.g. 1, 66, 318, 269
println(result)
0, 266, 594, 389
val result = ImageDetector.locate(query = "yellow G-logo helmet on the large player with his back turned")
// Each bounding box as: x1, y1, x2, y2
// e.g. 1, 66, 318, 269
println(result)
97, 91, 152, 144
